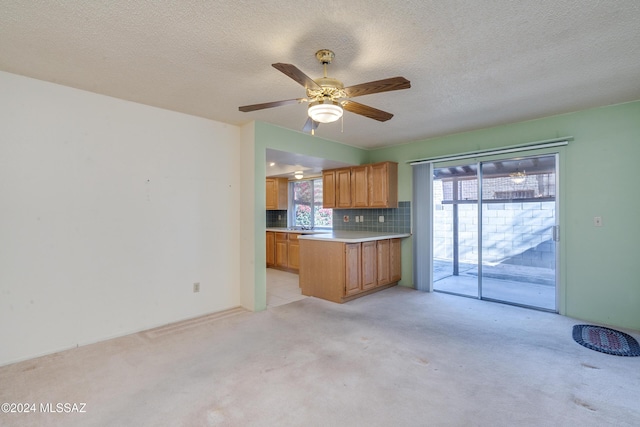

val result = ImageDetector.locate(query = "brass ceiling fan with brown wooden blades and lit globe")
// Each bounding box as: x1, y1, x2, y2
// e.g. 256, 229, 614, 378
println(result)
238, 49, 411, 134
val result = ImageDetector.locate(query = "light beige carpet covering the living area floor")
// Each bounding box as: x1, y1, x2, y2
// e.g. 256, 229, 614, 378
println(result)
0, 288, 640, 427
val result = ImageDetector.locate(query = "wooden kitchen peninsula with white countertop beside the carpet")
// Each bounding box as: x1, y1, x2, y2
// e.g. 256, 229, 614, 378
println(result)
298, 231, 410, 303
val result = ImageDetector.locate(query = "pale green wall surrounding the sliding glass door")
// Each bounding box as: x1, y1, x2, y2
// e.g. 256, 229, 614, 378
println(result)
368, 102, 640, 330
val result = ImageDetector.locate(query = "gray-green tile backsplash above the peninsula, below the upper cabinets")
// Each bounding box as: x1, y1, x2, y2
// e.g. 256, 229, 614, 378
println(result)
333, 202, 411, 233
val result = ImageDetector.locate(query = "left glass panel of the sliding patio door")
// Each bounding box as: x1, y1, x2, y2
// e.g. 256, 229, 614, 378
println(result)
433, 164, 479, 298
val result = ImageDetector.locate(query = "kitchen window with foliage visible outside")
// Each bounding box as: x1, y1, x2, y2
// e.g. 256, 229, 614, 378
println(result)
289, 178, 333, 228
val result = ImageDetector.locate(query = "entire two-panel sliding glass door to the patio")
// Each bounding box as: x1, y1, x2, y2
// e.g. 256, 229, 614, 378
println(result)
433, 154, 557, 311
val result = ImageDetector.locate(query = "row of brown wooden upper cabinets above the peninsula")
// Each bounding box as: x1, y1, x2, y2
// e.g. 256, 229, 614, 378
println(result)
322, 162, 398, 209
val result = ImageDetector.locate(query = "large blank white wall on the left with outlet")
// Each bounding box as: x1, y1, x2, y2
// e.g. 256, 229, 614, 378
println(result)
0, 72, 241, 365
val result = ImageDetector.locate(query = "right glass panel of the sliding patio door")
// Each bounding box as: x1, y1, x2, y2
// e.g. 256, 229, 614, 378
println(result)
480, 155, 556, 311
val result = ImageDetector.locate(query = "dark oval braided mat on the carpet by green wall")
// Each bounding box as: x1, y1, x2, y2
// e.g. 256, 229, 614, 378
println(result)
573, 325, 640, 356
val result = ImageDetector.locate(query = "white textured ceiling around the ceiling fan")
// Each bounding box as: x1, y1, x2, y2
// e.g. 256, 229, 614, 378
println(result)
0, 0, 640, 148
